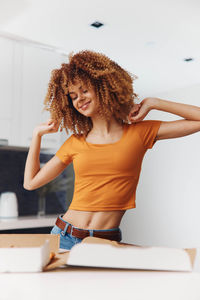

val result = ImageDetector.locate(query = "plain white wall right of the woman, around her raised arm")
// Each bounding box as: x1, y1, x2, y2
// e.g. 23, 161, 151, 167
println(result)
121, 85, 200, 247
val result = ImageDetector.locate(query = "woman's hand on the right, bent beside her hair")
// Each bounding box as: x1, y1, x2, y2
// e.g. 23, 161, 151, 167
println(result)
128, 98, 152, 123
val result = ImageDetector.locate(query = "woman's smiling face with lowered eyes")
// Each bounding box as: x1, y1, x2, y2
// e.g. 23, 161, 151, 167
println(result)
69, 81, 98, 117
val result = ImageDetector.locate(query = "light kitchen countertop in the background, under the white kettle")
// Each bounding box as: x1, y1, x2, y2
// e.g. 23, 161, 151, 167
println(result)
0, 215, 58, 230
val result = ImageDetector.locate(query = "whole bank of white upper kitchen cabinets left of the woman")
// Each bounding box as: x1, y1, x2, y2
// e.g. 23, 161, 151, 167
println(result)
0, 37, 67, 149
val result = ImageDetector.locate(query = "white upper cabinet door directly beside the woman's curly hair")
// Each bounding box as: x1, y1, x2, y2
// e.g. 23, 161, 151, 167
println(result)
20, 46, 63, 148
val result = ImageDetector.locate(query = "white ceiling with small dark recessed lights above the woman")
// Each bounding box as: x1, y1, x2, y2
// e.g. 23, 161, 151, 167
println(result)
0, 0, 200, 97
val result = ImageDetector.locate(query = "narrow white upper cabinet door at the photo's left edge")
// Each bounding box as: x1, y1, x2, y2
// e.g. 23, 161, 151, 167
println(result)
0, 37, 13, 140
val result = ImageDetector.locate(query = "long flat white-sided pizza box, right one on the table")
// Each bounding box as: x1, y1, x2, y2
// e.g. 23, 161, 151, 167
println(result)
45, 237, 197, 271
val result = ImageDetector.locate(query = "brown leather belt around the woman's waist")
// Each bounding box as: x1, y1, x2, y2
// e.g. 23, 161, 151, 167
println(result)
55, 217, 121, 242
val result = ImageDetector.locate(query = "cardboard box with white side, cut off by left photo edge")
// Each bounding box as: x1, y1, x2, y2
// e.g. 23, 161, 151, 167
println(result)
0, 234, 60, 272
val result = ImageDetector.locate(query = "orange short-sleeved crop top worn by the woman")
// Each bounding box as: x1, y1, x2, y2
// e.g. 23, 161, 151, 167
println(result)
56, 120, 161, 211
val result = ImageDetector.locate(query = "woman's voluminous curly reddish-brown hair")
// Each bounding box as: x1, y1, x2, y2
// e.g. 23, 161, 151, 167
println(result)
44, 50, 137, 136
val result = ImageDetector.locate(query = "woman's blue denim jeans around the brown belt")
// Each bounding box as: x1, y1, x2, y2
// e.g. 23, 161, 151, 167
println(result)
51, 216, 121, 250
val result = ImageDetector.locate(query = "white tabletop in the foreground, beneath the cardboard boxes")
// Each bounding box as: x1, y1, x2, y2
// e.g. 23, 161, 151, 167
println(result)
0, 267, 200, 300
